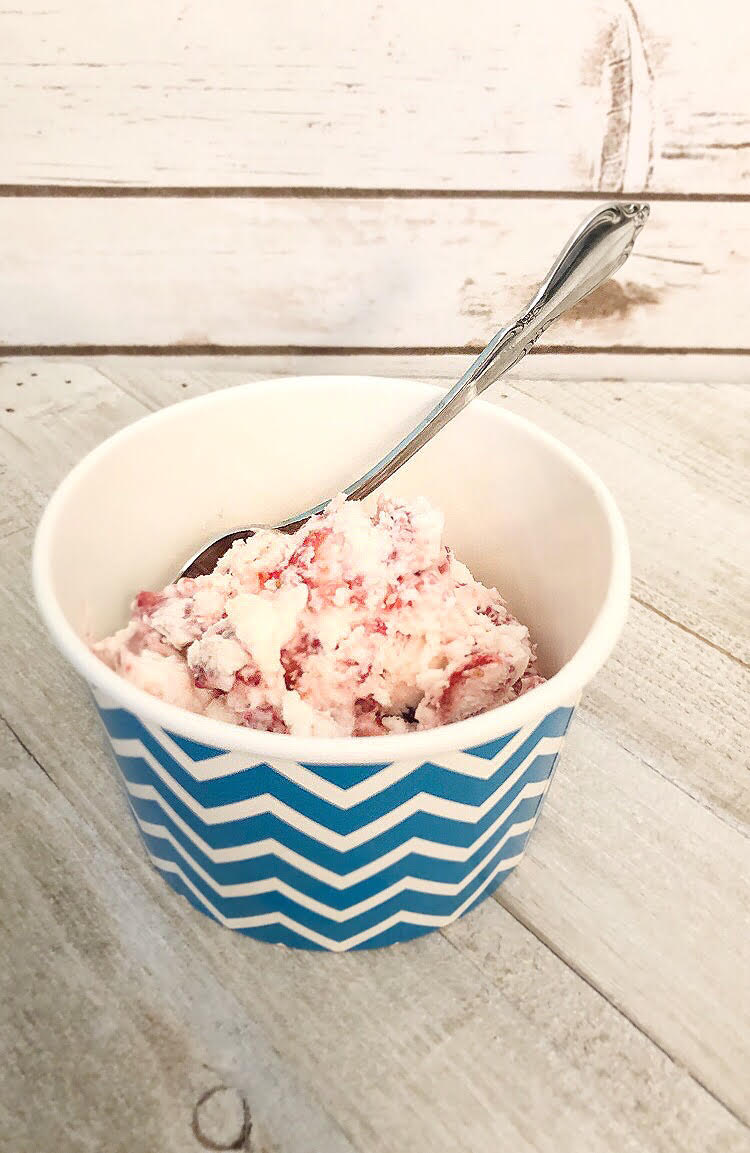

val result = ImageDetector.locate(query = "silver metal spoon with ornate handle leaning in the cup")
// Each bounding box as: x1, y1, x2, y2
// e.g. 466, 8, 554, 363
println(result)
180, 203, 650, 577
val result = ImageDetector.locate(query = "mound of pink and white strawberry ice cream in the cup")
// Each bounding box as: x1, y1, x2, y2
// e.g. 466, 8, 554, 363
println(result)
93, 496, 543, 737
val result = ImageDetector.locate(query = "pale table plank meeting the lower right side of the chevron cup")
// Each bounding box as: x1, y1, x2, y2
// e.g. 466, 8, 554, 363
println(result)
497, 724, 750, 1120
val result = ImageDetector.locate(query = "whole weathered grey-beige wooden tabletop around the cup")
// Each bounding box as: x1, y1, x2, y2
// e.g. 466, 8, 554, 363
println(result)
0, 356, 750, 1153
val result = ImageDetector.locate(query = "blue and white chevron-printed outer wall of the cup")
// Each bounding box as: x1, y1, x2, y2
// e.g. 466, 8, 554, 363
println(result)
97, 698, 573, 951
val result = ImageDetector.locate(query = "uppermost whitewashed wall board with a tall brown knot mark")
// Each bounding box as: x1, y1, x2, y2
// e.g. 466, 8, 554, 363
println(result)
0, 0, 750, 194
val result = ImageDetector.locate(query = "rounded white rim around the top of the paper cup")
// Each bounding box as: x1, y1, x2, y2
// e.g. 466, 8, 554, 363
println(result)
32, 376, 630, 764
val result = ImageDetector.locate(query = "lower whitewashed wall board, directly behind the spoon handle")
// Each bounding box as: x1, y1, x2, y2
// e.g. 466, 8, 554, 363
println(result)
0, 197, 750, 348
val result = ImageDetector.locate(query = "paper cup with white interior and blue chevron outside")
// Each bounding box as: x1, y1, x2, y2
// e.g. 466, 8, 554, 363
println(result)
33, 377, 629, 950
